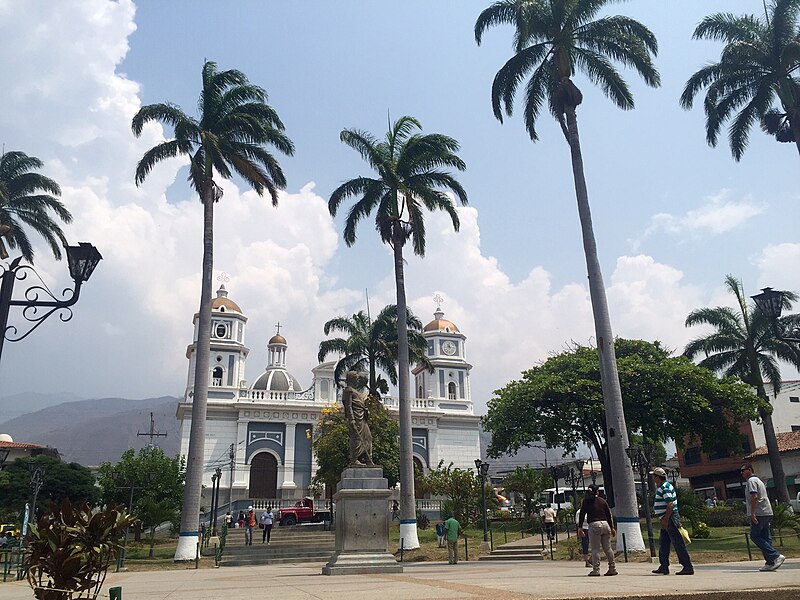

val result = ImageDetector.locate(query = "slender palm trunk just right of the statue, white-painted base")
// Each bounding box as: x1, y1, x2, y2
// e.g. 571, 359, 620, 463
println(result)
392, 222, 419, 550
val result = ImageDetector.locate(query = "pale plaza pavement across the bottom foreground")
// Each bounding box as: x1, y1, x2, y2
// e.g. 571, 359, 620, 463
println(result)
0, 559, 800, 600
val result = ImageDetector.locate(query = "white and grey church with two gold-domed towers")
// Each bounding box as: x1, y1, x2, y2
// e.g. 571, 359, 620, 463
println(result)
177, 285, 481, 504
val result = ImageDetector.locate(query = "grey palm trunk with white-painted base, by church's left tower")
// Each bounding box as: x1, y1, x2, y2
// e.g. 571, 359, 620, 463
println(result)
175, 180, 214, 562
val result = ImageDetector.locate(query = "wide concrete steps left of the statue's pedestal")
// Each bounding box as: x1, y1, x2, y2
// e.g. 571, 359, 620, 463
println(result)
220, 525, 336, 567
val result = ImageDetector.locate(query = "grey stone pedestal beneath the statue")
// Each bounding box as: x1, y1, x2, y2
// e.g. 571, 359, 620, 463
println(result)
322, 467, 403, 575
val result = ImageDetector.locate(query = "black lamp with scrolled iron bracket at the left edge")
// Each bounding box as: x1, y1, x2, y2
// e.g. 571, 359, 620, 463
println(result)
0, 242, 103, 358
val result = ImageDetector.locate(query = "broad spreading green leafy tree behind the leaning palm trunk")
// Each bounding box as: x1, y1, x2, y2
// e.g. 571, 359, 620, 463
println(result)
483, 338, 758, 498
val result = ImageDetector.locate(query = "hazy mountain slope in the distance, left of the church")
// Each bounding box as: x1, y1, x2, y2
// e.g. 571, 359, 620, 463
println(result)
0, 396, 180, 466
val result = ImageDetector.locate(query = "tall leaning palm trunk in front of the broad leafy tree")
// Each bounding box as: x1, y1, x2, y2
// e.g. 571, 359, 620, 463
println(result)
566, 106, 644, 550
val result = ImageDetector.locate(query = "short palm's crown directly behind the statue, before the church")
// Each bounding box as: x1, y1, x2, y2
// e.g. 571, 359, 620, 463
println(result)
317, 304, 433, 399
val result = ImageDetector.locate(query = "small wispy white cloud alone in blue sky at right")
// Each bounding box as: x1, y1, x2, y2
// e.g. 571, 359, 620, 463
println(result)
630, 189, 766, 252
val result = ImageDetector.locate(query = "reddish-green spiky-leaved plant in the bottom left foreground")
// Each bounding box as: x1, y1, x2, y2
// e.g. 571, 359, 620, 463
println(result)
25, 499, 135, 600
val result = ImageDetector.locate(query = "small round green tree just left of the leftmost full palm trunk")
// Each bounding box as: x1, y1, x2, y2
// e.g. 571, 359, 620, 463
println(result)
97, 447, 186, 557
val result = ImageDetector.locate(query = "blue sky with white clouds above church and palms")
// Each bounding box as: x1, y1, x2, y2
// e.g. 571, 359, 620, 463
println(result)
0, 0, 800, 420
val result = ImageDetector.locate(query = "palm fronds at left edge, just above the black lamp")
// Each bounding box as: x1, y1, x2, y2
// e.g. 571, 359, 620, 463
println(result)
0, 152, 72, 264
